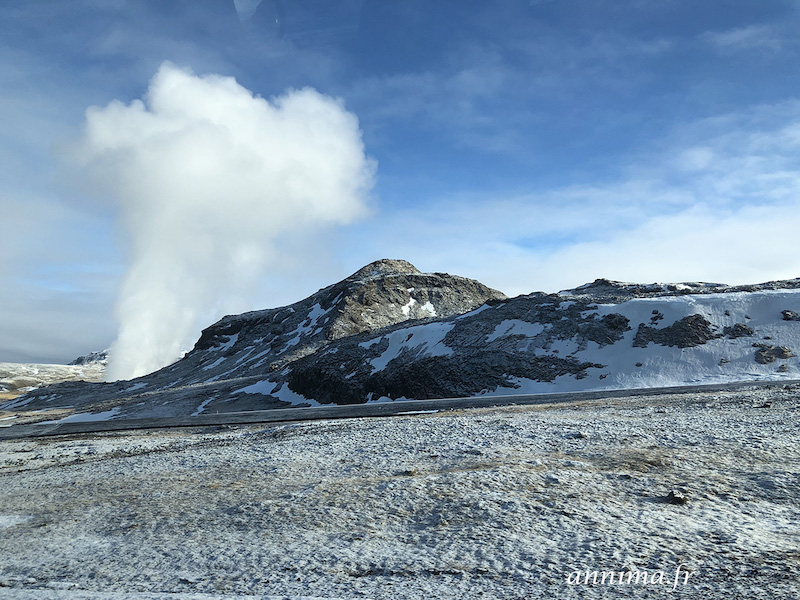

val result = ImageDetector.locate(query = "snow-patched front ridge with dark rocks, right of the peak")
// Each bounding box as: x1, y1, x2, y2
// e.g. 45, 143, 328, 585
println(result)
284, 289, 800, 403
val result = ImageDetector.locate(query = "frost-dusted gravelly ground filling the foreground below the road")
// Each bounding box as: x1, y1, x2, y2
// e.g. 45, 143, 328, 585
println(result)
0, 386, 800, 600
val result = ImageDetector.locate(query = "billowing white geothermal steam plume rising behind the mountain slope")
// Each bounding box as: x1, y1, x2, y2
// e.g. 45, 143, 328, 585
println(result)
79, 63, 373, 380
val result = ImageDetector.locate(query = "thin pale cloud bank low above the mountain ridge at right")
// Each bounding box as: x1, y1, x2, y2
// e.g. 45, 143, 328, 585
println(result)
348, 102, 800, 294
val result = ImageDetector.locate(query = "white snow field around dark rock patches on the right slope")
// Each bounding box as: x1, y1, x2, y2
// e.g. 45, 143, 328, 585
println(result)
487, 289, 800, 395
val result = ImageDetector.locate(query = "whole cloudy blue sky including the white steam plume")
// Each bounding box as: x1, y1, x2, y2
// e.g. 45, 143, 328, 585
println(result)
0, 0, 800, 368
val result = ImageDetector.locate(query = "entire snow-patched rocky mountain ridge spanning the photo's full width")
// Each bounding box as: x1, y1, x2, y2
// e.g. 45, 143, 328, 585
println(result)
0, 260, 800, 419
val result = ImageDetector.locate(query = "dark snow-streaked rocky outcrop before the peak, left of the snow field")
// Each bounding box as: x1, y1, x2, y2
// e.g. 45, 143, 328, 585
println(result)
284, 294, 630, 403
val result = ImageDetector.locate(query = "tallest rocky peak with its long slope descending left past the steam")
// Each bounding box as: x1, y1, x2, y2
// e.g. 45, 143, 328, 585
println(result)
0, 260, 506, 417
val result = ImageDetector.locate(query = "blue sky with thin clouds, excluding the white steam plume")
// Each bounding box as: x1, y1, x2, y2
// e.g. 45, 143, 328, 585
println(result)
0, 0, 800, 362
